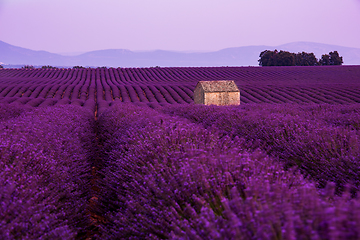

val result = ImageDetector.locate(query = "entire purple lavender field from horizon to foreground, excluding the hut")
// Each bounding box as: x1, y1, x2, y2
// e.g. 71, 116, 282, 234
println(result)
0, 66, 360, 239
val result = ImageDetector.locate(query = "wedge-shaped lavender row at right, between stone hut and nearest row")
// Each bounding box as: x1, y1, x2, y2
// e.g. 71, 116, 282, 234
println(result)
164, 104, 360, 195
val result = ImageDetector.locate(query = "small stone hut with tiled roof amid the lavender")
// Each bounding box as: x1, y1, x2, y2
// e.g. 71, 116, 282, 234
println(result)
194, 80, 240, 106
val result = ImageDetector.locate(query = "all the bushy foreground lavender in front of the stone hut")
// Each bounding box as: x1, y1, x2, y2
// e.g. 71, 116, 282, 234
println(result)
0, 100, 360, 239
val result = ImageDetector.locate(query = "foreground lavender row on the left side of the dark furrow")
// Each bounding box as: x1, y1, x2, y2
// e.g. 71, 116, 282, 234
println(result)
0, 105, 95, 239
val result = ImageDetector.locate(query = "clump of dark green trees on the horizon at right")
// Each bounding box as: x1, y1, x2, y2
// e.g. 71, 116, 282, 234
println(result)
258, 49, 343, 67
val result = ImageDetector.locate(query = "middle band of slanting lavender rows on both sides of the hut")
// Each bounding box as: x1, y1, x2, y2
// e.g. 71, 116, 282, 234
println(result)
4, 83, 360, 108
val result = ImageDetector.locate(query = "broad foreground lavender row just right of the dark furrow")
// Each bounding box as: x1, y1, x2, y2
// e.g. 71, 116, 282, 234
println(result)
98, 104, 360, 239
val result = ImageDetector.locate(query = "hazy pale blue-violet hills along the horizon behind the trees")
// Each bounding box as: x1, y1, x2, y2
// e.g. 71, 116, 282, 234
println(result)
0, 41, 360, 67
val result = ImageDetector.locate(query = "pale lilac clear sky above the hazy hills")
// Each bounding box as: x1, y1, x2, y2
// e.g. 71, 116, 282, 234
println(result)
0, 0, 360, 53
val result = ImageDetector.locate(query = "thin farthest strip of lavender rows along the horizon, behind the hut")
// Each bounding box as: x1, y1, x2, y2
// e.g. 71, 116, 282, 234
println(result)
0, 66, 360, 85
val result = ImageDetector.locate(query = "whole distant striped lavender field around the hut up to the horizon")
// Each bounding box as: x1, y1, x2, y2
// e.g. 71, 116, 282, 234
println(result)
0, 66, 360, 115
